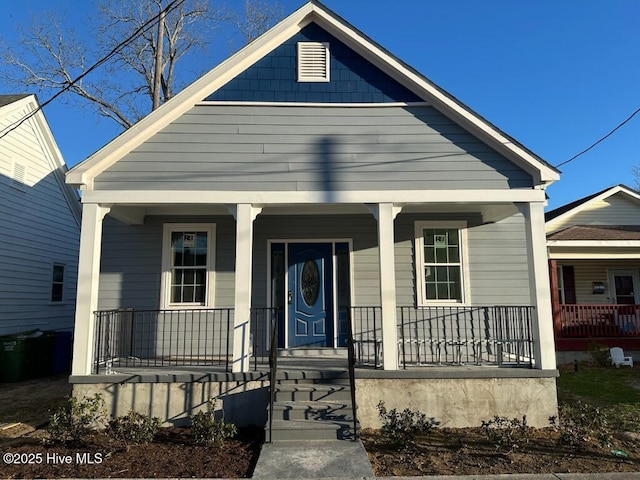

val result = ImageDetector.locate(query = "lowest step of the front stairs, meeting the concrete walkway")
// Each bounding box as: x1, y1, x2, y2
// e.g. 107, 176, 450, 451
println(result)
265, 419, 354, 442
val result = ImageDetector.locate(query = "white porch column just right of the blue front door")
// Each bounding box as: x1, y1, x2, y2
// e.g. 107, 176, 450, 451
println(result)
369, 203, 401, 370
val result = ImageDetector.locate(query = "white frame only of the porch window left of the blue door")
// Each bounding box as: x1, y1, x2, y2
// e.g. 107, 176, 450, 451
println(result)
160, 223, 216, 310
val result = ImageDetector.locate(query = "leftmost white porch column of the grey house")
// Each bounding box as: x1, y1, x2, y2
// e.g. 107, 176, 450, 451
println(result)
71, 203, 109, 375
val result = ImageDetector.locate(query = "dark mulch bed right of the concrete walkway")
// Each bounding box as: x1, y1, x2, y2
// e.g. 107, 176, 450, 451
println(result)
362, 428, 640, 476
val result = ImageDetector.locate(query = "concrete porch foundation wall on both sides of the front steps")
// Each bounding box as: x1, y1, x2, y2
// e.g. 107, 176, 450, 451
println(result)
72, 372, 558, 428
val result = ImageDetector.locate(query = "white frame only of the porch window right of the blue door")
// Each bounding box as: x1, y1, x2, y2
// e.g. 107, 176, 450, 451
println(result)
414, 220, 470, 307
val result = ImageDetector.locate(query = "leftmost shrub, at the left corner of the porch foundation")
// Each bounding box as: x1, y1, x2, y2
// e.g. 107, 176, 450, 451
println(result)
47, 393, 106, 443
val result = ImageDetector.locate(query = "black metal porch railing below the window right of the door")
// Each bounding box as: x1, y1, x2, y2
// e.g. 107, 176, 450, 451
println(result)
398, 306, 534, 368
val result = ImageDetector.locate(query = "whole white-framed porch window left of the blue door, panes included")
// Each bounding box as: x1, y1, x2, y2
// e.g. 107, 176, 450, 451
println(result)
161, 224, 215, 308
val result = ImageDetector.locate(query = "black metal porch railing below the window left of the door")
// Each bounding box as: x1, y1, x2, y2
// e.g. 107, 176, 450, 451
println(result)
94, 308, 233, 373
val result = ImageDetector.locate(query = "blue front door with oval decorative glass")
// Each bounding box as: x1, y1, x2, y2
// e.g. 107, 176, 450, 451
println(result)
287, 243, 333, 347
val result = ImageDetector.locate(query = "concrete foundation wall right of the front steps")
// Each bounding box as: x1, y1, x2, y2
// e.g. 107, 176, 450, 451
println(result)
356, 378, 558, 428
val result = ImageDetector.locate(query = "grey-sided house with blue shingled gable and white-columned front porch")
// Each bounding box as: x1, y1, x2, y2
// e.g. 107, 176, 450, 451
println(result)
67, 0, 559, 427
